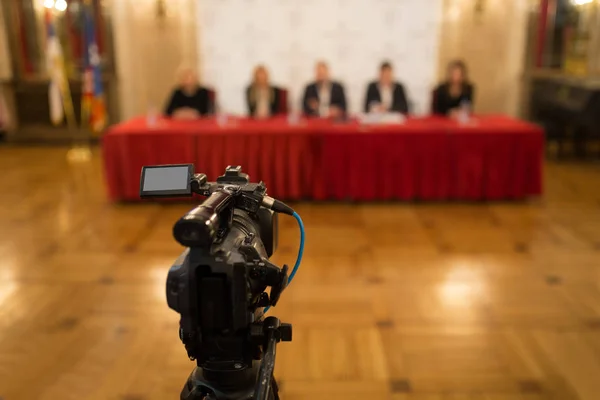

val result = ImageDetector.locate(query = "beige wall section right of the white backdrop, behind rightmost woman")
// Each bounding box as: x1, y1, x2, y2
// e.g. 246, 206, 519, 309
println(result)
438, 0, 534, 116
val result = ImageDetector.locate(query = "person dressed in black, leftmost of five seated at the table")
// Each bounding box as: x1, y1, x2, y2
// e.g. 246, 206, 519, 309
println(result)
165, 66, 213, 120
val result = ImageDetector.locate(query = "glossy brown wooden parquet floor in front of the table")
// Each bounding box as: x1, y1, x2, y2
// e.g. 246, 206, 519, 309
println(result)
0, 147, 600, 400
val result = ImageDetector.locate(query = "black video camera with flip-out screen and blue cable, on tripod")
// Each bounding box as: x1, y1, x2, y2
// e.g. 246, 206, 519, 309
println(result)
140, 164, 304, 400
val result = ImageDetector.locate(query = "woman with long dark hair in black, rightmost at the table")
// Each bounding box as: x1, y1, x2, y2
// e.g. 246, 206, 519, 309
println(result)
433, 60, 475, 118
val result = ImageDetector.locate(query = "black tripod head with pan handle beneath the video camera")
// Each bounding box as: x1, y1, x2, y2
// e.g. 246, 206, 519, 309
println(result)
181, 317, 292, 400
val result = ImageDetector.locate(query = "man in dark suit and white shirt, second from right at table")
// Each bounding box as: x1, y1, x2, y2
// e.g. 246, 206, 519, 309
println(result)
365, 61, 408, 114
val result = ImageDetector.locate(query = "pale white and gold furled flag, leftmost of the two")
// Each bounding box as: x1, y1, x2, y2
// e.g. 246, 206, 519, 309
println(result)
45, 10, 75, 127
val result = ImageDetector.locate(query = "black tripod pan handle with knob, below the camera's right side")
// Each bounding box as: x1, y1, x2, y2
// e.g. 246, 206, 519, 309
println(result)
251, 317, 292, 400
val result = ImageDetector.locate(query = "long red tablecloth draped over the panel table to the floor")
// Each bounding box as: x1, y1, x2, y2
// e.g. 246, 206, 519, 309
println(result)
103, 116, 544, 200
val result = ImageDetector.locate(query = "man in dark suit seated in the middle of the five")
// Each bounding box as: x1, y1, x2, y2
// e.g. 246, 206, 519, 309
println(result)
302, 61, 346, 119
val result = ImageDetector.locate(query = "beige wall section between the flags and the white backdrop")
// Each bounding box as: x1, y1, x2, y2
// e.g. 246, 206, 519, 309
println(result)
107, 0, 198, 120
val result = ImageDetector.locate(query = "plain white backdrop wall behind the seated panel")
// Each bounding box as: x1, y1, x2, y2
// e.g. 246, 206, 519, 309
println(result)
197, 0, 442, 114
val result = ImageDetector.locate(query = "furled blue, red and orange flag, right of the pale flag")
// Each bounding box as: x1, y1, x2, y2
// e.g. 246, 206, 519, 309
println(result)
81, 0, 106, 132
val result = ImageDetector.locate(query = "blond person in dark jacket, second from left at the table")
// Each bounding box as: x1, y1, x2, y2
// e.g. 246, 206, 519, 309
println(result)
246, 65, 279, 119
